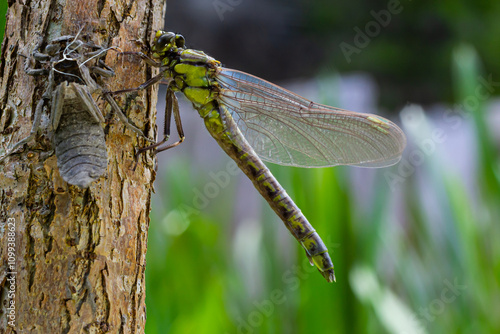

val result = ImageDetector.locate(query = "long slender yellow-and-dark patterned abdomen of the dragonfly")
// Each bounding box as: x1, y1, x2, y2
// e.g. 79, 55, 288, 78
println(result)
200, 102, 335, 282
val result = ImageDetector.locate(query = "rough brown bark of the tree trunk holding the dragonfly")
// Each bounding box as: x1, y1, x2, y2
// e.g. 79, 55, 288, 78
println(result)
0, 0, 163, 333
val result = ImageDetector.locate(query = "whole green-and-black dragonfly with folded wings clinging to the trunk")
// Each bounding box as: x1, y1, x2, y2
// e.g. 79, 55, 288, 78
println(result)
114, 30, 406, 282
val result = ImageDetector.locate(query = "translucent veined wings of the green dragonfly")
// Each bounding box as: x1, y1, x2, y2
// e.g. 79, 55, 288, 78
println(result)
216, 68, 406, 167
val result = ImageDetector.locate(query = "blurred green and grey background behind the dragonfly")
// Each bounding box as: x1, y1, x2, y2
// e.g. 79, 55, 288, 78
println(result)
0, 0, 500, 334
